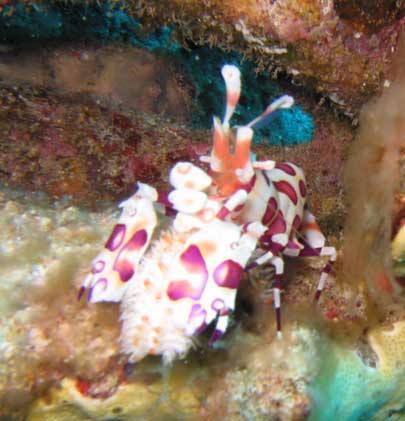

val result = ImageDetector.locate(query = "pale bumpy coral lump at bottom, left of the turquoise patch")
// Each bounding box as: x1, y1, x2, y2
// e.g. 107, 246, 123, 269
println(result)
201, 325, 322, 421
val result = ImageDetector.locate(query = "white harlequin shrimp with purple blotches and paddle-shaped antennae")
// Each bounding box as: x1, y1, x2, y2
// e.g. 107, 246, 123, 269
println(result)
79, 65, 336, 362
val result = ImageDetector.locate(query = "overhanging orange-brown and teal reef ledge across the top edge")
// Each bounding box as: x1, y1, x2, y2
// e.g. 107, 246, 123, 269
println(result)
0, 0, 404, 116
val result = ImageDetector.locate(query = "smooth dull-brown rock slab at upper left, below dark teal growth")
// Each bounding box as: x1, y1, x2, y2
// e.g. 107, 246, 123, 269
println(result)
0, 44, 194, 117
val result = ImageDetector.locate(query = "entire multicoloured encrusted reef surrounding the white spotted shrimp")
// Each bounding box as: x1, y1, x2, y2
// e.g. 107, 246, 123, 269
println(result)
0, 0, 405, 421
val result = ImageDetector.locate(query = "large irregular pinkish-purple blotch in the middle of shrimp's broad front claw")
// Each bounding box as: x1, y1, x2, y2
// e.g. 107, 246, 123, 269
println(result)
167, 244, 208, 301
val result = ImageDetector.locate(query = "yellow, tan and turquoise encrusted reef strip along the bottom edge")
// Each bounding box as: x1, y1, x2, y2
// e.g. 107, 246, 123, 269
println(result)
23, 323, 405, 421
